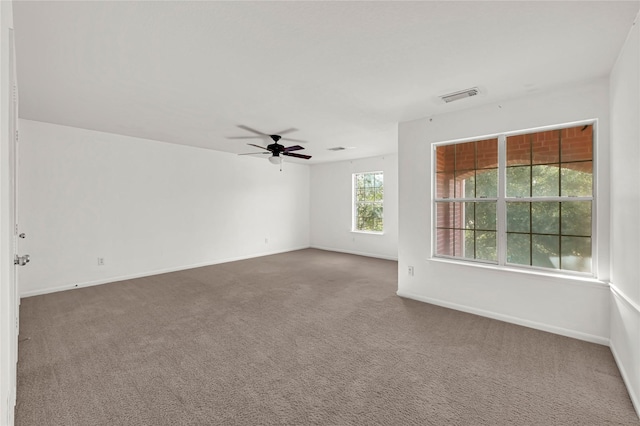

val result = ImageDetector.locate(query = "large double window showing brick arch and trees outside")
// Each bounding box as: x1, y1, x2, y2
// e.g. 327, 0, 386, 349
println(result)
434, 123, 594, 273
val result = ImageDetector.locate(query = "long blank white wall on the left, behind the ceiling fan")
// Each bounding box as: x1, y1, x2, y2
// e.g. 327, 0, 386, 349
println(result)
18, 120, 309, 296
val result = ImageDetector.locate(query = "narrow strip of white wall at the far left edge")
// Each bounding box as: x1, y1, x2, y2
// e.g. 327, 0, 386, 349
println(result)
0, 1, 18, 425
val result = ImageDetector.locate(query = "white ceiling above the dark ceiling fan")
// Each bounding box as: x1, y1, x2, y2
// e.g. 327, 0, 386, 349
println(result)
13, 1, 640, 163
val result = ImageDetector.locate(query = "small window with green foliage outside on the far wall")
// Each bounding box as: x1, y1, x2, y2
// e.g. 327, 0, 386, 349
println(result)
353, 172, 384, 232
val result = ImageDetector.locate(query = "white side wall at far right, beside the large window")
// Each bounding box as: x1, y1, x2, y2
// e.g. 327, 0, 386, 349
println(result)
610, 12, 640, 413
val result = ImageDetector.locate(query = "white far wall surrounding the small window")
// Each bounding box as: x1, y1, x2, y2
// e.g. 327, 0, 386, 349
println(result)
310, 154, 398, 259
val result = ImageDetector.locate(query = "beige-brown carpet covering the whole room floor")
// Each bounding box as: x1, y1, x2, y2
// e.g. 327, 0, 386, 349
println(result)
16, 249, 640, 425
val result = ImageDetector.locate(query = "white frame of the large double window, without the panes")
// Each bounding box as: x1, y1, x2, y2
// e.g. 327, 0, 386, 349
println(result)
430, 119, 598, 278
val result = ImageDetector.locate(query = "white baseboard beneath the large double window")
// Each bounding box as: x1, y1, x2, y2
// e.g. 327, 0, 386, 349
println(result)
396, 290, 609, 346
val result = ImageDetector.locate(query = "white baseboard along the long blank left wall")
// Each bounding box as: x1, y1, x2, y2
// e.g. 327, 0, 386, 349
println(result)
20, 246, 309, 298
